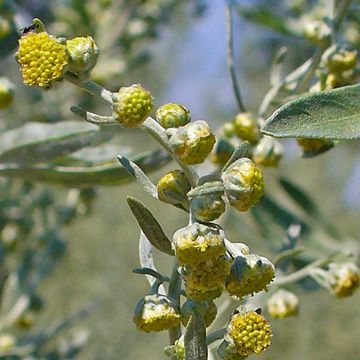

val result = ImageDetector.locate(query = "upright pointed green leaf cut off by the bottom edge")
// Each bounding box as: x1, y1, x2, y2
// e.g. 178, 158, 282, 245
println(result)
184, 309, 208, 360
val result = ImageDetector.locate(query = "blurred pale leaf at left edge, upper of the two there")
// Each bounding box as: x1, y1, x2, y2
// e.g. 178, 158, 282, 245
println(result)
0, 121, 99, 164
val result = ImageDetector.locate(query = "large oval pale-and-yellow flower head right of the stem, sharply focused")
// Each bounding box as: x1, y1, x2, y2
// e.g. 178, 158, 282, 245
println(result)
221, 158, 264, 211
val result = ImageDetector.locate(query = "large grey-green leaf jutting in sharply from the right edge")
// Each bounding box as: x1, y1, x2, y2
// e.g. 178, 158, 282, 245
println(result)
262, 85, 360, 140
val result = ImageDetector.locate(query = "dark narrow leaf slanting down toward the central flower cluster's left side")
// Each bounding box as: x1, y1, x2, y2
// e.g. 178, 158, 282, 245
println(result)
127, 197, 174, 255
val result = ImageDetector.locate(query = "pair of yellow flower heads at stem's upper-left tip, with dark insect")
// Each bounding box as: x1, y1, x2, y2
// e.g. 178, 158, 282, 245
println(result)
15, 19, 99, 88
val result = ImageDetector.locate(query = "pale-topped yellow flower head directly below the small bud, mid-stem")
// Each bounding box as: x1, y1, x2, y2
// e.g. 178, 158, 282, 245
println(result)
169, 120, 215, 165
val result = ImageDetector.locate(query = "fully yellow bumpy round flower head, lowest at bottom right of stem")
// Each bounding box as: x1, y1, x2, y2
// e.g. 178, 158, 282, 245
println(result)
225, 311, 272, 356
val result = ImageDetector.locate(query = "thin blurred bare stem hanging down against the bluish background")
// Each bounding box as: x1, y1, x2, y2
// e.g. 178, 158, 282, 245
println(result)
225, 3, 246, 112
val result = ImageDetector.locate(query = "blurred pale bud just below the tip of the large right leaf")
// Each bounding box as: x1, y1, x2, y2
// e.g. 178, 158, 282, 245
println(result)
252, 136, 284, 167
